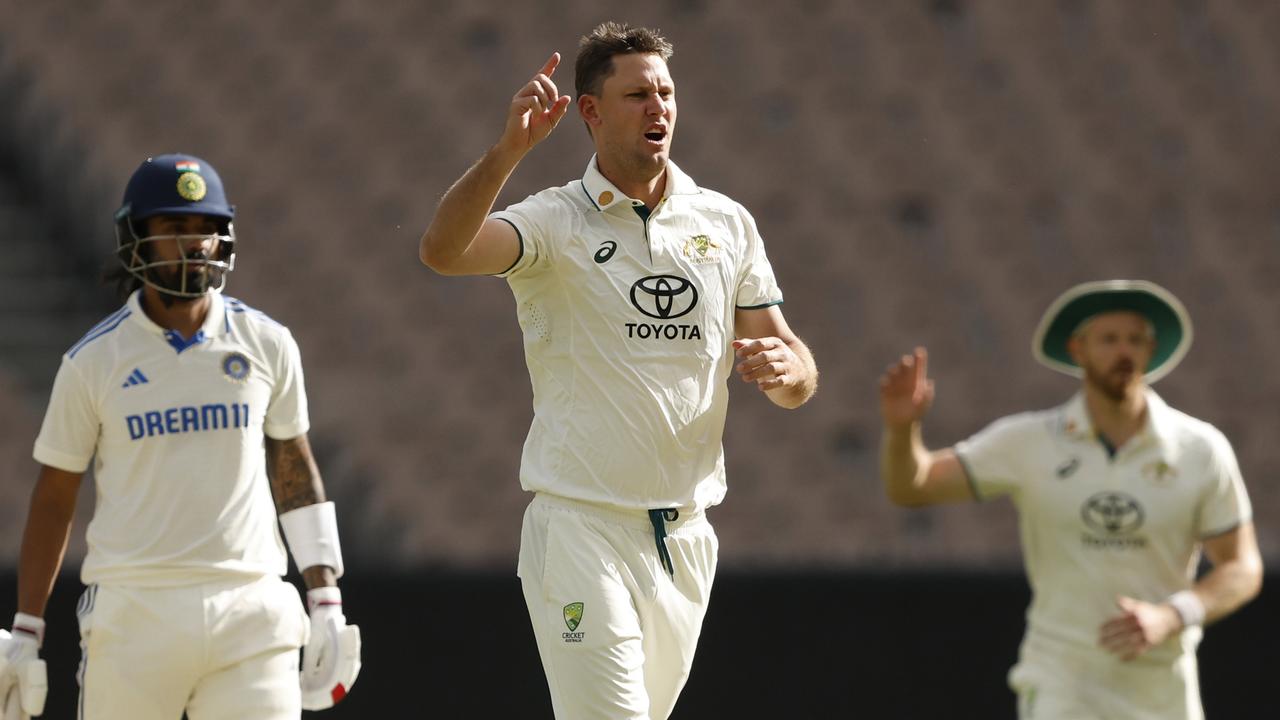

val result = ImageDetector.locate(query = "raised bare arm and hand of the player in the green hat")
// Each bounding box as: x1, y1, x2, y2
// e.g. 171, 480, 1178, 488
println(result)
879, 347, 973, 507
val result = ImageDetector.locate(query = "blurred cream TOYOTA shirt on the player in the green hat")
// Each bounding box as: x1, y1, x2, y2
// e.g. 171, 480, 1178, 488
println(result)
956, 389, 1251, 667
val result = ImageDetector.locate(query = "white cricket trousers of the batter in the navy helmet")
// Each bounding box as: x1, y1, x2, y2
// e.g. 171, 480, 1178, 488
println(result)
77, 577, 311, 720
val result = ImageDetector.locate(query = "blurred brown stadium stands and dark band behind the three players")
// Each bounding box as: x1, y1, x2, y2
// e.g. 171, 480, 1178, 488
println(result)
0, 0, 1280, 719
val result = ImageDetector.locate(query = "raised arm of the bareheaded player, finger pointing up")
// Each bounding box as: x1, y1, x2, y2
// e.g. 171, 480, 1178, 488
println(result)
417, 53, 571, 275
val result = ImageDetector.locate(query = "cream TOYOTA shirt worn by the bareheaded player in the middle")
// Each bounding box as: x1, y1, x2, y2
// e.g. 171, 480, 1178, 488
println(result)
492, 158, 782, 510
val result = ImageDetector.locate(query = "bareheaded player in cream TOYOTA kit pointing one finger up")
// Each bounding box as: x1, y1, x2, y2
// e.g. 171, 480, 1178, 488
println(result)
420, 23, 818, 719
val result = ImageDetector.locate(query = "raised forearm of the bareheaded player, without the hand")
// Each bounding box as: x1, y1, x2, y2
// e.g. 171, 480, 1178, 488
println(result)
419, 146, 524, 272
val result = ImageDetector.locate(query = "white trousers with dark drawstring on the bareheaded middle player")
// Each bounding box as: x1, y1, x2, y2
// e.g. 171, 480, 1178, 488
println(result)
518, 493, 719, 720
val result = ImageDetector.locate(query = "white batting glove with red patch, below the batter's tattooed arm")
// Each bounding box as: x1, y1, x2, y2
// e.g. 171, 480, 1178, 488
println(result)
299, 588, 360, 707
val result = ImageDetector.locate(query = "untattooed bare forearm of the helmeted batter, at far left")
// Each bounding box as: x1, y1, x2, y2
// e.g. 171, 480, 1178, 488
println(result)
18, 478, 78, 609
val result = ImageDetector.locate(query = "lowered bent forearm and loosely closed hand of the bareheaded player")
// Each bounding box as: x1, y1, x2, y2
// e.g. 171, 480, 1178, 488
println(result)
733, 305, 818, 410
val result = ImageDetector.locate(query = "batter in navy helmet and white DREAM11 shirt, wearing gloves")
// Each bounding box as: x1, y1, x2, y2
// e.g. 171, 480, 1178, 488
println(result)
0, 155, 360, 720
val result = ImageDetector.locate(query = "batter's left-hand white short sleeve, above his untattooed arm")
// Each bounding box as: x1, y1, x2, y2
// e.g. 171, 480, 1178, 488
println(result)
32, 356, 101, 473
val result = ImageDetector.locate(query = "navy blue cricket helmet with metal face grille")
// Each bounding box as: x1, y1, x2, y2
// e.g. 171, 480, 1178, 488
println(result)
115, 154, 236, 297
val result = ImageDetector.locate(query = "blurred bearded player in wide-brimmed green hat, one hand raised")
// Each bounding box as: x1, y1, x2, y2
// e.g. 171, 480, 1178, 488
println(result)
881, 281, 1262, 720
